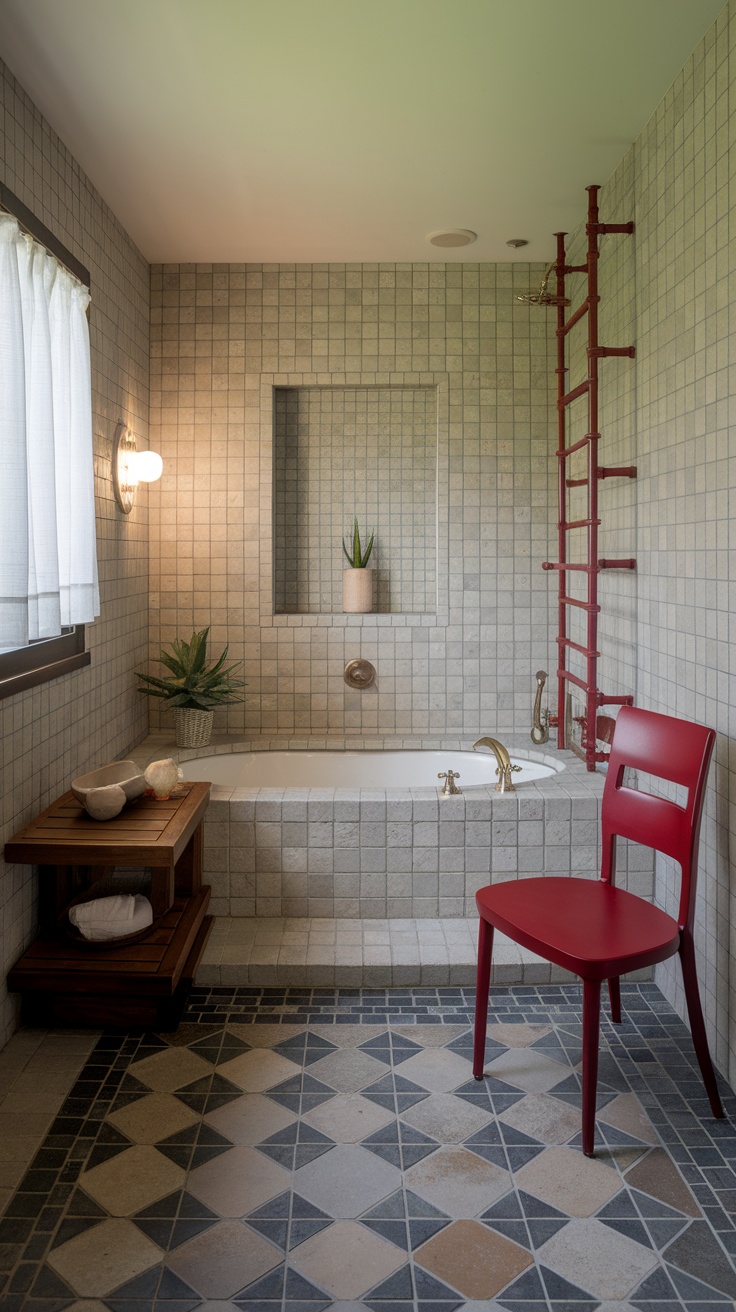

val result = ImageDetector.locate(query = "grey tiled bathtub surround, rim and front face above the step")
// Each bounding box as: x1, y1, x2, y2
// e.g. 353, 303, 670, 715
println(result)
135, 735, 652, 920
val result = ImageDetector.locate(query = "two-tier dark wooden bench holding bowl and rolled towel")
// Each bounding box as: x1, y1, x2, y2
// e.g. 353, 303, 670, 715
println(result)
5, 783, 213, 1029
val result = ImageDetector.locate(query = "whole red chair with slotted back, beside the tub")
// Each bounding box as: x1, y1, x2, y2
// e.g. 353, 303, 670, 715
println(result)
472, 707, 724, 1157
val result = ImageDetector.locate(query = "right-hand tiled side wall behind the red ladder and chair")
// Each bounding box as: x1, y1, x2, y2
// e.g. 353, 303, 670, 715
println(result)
582, 0, 736, 1082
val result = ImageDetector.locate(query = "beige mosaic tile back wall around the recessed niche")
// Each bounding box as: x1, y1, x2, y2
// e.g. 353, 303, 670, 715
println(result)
151, 264, 554, 737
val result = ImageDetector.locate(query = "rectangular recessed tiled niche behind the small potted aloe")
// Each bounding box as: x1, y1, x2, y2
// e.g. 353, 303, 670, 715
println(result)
273, 386, 437, 614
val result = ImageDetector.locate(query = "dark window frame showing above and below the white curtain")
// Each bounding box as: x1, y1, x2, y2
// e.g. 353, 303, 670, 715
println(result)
0, 182, 92, 699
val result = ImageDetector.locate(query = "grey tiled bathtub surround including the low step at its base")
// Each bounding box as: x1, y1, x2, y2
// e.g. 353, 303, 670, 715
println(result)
127, 735, 652, 985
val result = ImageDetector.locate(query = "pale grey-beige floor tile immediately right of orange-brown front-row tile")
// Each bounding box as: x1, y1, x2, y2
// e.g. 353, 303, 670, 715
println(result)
537, 1219, 659, 1299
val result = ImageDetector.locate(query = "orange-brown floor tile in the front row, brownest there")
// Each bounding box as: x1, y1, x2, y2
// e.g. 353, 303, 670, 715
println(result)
415, 1220, 534, 1300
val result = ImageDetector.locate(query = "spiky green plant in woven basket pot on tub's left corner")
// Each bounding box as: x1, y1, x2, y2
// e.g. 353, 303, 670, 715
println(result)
136, 628, 245, 747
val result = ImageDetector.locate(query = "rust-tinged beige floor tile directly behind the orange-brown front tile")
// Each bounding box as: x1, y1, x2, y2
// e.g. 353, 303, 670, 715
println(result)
405, 1147, 512, 1219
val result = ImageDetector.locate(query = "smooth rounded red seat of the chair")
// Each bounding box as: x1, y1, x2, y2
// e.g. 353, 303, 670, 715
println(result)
476, 875, 680, 980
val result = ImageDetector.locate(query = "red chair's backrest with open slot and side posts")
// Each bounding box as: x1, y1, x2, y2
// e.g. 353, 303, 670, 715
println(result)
601, 706, 715, 929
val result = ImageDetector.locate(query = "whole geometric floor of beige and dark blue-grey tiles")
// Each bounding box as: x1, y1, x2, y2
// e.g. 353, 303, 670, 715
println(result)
0, 984, 736, 1312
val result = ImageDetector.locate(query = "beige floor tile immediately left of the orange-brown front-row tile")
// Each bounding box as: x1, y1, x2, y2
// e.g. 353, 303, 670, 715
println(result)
290, 1220, 407, 1299
